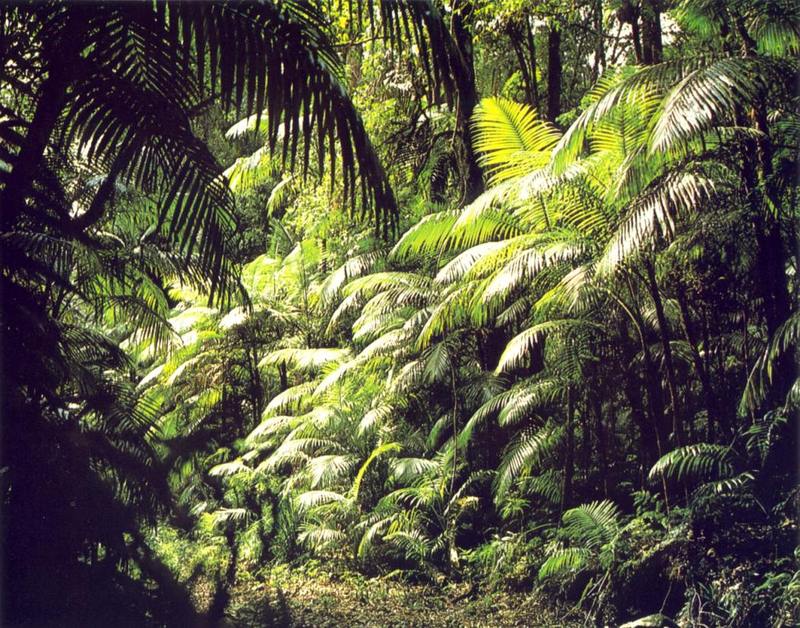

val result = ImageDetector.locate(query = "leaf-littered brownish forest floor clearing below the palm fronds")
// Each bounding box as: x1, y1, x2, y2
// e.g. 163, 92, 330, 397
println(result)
212, 568, 580, 628
